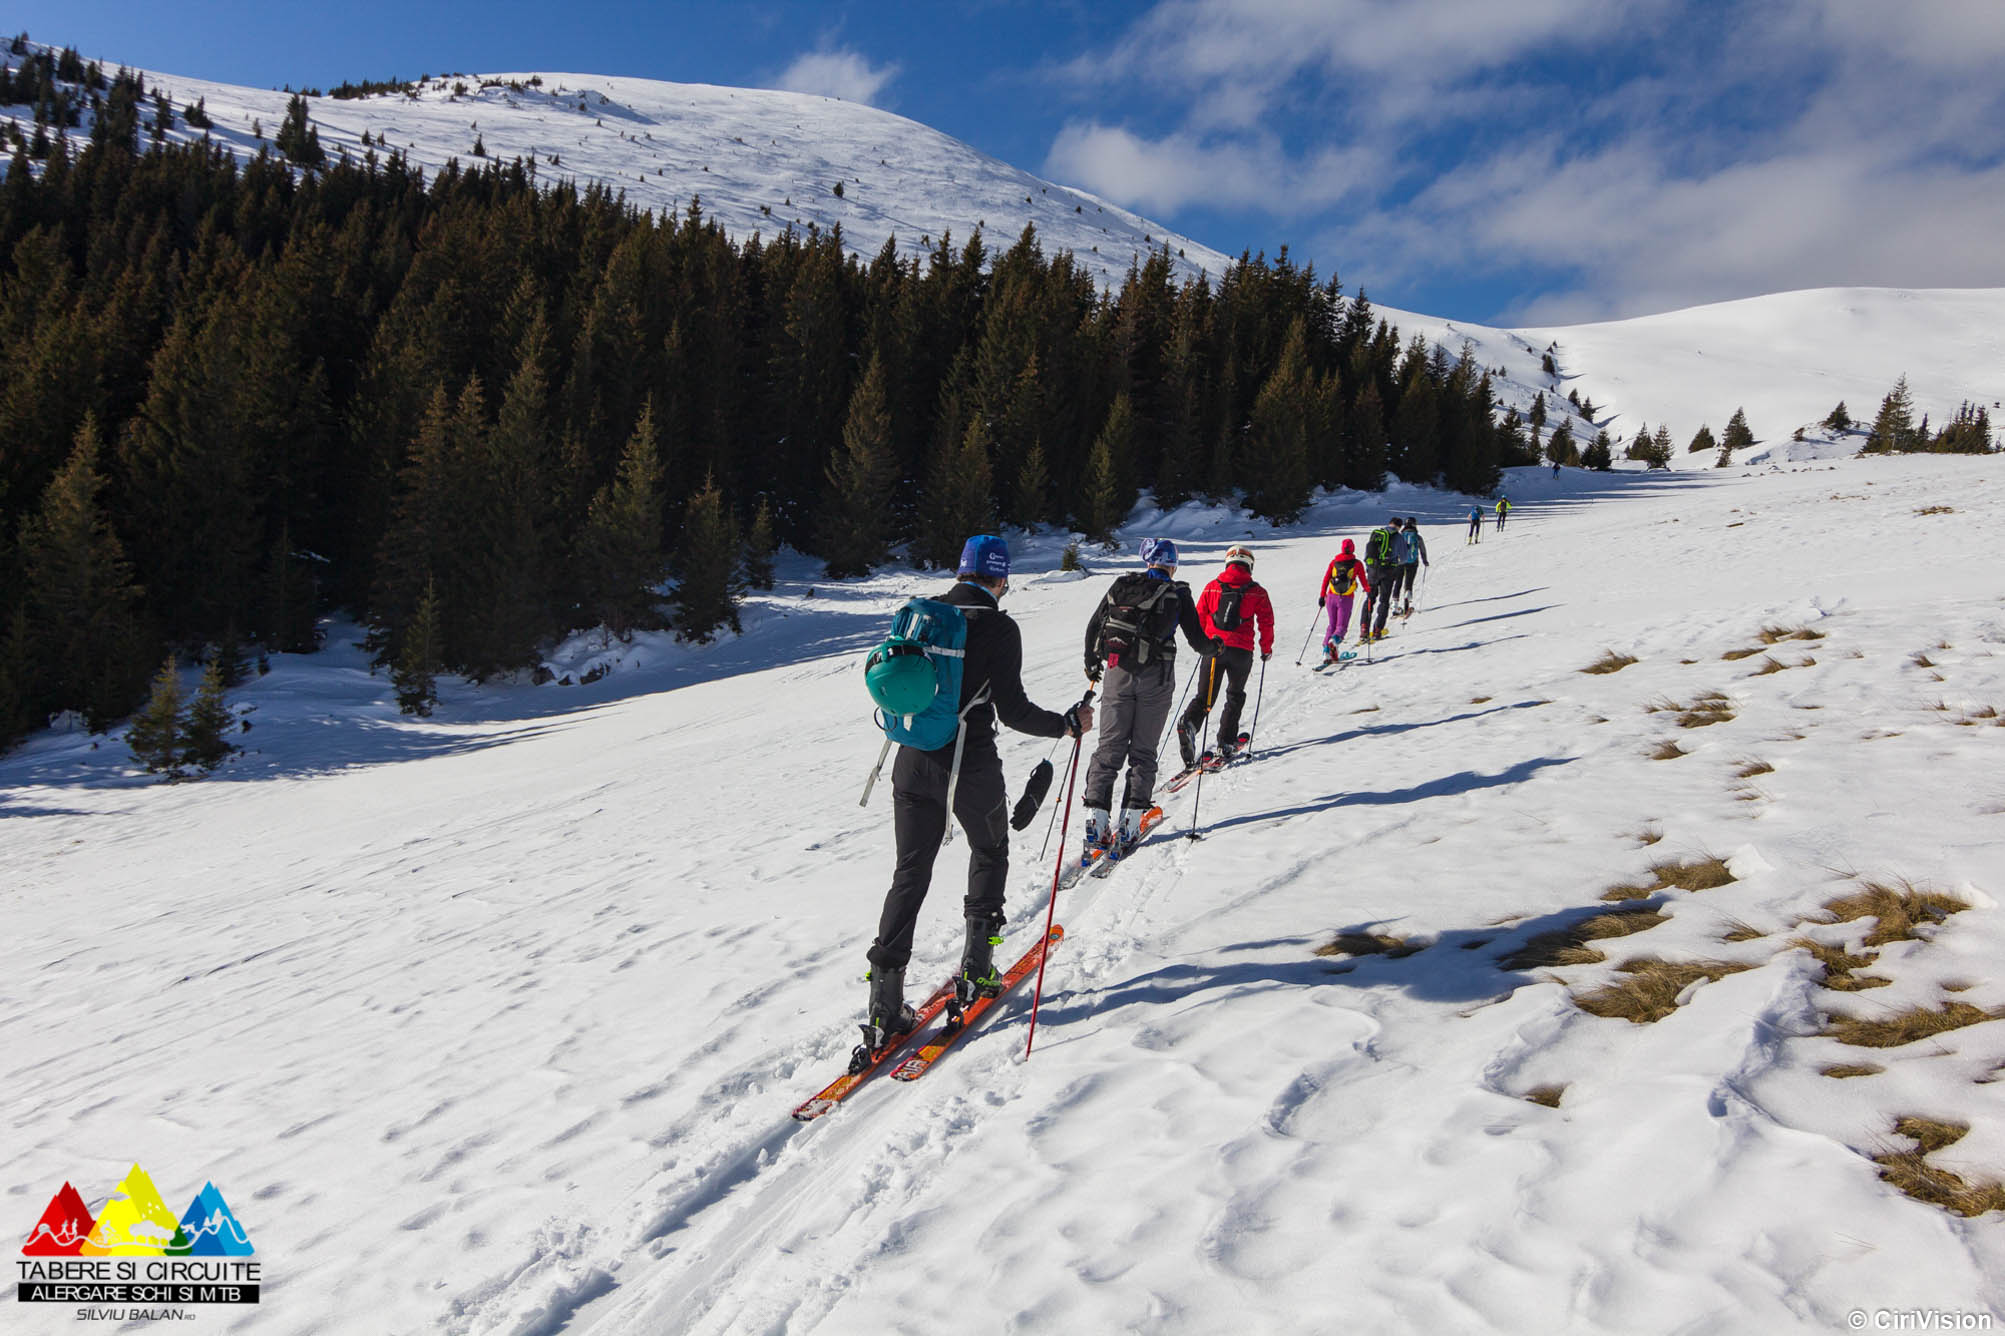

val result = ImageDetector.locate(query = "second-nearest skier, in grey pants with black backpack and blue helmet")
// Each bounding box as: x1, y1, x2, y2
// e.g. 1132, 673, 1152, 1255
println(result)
1085, 538, 1211, 849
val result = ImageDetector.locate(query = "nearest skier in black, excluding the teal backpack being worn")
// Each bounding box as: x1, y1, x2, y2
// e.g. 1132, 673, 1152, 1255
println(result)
870, 534, 1093, 1047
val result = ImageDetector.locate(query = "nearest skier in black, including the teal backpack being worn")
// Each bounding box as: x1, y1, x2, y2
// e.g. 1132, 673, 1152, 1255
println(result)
864, 534, 1093, 1051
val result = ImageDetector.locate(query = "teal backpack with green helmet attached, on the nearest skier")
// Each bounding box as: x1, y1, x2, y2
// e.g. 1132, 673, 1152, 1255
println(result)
858, 598, 988, 822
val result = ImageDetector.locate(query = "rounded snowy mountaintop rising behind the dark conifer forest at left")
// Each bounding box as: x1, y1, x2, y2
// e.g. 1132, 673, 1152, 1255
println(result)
6, 55, 1227, 285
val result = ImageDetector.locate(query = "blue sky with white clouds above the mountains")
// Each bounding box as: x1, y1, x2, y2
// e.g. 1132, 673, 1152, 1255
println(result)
27, 0, 2005, 323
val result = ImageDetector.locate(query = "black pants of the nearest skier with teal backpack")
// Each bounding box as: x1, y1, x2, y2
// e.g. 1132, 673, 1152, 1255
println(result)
870, 738, 1009, 969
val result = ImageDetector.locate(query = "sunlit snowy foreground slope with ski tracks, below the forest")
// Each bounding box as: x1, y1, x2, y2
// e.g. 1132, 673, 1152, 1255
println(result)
0, 457, 2005, 1334
